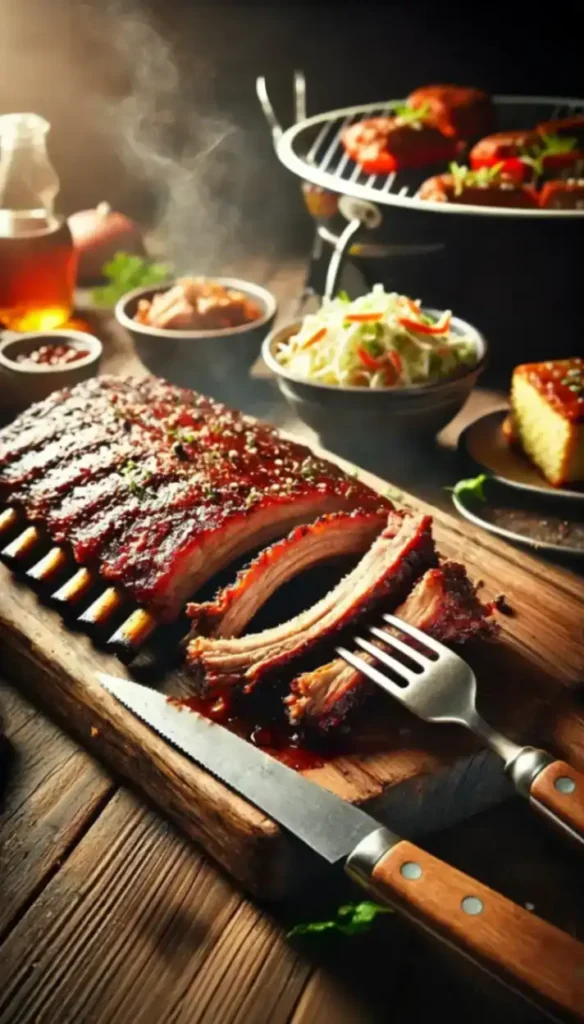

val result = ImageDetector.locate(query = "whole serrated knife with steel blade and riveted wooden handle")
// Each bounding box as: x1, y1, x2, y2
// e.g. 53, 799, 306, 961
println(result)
97, 673, 584, 1021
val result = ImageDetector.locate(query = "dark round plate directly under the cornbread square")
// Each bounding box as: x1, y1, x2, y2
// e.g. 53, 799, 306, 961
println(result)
459, 409, 584, 502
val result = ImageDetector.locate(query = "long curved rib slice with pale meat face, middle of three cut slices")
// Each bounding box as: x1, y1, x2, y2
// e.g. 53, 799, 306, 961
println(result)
186, 512, 435, 691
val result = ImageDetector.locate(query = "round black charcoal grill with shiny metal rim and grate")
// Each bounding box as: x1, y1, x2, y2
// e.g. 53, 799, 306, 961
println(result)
256, 72, 584, 372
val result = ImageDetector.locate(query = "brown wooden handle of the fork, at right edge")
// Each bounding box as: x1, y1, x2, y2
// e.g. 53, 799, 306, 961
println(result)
530, 761, 584, 847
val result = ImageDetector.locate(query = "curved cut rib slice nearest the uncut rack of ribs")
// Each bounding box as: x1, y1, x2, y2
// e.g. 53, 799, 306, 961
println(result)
186, 511, 387, 637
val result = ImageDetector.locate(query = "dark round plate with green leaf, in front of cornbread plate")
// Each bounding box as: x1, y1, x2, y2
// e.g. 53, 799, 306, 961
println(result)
452, 480, 584, 558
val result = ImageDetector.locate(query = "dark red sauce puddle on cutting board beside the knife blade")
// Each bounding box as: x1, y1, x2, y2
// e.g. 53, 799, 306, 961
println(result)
168, 696, 330, 771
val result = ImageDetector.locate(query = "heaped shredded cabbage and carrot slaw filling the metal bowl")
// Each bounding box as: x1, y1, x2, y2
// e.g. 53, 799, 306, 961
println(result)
276, 285, 476, 388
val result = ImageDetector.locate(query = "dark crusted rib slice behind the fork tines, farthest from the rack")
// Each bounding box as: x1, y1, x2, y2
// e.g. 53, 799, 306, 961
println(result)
284, 562, 495, 730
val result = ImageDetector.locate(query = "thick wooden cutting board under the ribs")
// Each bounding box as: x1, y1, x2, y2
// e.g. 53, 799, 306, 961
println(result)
0, 436, 584, 899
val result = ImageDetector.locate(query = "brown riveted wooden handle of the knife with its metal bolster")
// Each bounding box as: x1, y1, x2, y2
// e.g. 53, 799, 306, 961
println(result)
346, 829, 584, 1021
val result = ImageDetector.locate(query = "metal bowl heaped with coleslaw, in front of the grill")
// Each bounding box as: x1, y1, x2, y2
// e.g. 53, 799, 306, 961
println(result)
262, 285, 487, 443
